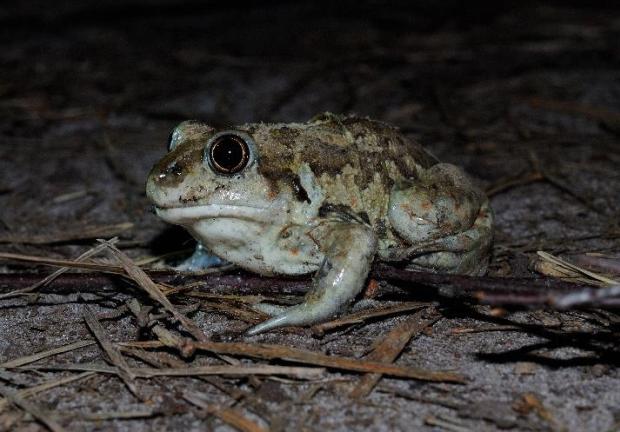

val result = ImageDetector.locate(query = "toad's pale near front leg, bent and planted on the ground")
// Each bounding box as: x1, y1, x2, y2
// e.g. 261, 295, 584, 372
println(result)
247, 221, 377, 335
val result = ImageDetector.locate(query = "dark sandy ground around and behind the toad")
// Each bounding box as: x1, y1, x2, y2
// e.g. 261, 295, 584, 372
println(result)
0, 0, 620, 432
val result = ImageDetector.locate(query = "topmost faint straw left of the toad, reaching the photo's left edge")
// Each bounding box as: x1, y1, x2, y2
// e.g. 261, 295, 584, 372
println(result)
0, 222, 133, 245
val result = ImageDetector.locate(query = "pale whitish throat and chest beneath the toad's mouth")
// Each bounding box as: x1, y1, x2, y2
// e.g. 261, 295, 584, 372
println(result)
189, 218, 323, 275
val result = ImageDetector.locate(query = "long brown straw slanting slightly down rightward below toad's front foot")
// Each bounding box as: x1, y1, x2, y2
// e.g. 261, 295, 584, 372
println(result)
188, 342, 465, 383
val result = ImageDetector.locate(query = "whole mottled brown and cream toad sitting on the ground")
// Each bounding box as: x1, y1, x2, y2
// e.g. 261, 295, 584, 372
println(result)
146, 113, 493, 335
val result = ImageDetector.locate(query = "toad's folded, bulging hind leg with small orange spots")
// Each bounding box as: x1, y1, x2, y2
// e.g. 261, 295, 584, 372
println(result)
388, 164, 493, 275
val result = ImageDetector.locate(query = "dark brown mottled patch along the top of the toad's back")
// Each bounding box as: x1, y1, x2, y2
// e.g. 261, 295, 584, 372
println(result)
243, 114, 437, 185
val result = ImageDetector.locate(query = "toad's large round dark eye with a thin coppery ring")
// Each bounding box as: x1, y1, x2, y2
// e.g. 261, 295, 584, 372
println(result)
207, 133, 250, 174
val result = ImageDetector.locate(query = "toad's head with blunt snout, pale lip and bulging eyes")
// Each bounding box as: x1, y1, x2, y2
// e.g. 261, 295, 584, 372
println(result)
146, 121, 286, 229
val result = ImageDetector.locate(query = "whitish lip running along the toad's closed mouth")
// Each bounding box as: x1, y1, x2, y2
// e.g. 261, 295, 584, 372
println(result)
155, 204, 274, 225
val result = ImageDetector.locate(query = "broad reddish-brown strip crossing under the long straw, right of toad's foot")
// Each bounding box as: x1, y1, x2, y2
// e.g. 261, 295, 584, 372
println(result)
349, 310, 440, 398
